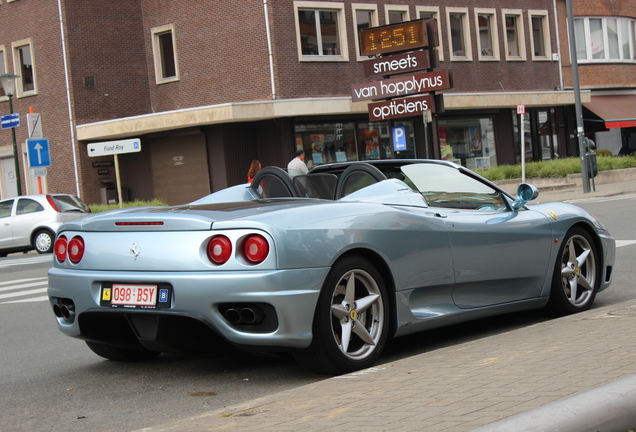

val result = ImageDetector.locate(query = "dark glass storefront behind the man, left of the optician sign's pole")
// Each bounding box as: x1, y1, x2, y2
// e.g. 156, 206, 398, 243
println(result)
295, 121, 416, 169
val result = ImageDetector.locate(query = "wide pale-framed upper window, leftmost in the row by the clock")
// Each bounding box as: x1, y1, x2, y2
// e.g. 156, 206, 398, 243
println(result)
294, 1, 349, 61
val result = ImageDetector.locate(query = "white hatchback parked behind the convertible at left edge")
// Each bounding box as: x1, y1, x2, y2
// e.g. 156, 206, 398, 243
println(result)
0, 194, 91, 257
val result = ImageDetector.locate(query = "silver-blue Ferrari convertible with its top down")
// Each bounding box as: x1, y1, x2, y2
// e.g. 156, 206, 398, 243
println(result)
48, 160, 615, 374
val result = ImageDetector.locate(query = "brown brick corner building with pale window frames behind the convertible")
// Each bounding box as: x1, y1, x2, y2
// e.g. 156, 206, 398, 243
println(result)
0, 0, 635, 204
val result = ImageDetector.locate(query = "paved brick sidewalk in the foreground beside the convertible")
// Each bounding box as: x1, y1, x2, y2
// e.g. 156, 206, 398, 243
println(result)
139, 300, 636, 432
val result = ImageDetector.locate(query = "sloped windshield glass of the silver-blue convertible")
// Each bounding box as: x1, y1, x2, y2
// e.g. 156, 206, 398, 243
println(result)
401, 163, 507, 210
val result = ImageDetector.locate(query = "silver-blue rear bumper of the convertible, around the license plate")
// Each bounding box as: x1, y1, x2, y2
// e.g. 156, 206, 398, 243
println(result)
48, 268, 329, 348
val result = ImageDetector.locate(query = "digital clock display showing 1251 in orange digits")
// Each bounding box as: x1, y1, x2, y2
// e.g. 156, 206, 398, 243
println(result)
360, 20, 428, 56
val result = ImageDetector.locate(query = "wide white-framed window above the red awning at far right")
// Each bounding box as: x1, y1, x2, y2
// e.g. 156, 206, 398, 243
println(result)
574, 17, 636, 63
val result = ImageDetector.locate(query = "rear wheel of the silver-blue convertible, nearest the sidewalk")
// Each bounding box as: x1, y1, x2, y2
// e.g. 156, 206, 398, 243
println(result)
294, 257, 389, 375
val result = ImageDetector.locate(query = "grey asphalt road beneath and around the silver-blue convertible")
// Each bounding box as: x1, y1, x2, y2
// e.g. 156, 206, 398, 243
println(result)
0, 198, 636, 432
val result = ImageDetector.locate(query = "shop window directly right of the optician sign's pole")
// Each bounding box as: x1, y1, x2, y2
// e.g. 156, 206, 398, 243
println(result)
438, 118, 497, 170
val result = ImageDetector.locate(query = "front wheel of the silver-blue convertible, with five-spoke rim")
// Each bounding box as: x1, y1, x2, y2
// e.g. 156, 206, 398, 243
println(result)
546, 227, 601, 316
